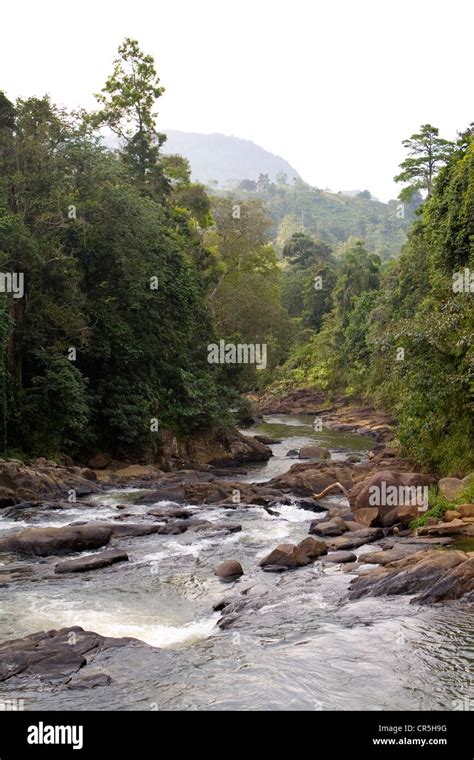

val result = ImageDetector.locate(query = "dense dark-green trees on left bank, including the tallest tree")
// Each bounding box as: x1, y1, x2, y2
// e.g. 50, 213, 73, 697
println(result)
0, 52, 227, 455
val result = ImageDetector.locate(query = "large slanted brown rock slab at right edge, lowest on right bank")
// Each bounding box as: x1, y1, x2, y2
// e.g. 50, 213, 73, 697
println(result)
349, 549, 468, 600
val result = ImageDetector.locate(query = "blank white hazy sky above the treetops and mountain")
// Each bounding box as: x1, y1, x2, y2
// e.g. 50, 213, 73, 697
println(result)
0, 0, 474, 200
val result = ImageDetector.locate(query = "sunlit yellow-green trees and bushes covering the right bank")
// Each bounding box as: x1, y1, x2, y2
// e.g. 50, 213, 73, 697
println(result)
277, 130, 474, 475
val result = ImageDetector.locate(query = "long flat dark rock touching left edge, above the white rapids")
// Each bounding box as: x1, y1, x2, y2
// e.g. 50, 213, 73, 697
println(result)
0, 524, 113, 557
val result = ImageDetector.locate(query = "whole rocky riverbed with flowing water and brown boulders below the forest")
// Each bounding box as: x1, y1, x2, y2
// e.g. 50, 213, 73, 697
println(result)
0, 410, 474, 709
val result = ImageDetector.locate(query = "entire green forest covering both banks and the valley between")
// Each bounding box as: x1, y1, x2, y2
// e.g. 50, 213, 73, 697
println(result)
0, 40, 474, 474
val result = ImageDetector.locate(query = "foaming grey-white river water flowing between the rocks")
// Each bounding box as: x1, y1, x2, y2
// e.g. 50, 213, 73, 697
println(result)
0, 416, 473, 710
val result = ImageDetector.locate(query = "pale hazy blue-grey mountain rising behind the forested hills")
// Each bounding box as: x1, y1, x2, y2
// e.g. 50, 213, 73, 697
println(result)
162, 129, 300, 187
